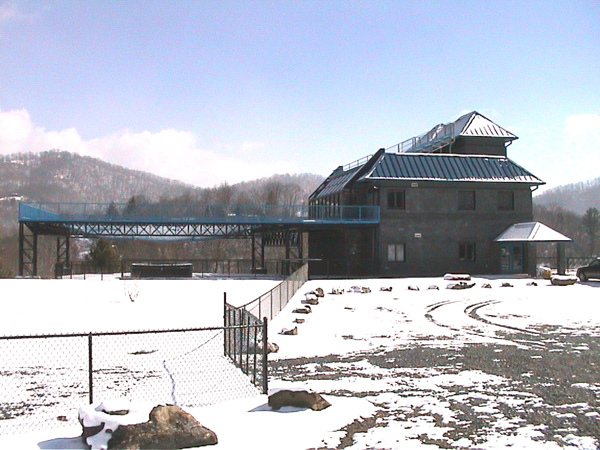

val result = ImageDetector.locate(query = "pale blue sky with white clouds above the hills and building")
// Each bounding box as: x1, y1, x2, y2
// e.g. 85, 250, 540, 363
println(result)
0, 0, 600, 187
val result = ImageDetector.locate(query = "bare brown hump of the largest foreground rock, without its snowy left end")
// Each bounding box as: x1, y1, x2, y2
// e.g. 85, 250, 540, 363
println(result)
108, 405, 218, 450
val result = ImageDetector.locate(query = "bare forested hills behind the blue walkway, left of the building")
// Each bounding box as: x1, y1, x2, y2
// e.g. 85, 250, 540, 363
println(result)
0, 150, 324, 232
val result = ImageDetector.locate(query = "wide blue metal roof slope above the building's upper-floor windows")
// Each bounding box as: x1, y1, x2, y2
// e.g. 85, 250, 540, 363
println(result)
360, 153, 544, 185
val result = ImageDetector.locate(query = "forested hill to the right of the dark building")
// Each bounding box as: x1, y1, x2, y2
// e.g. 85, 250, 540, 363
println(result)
533, 178, 600, 215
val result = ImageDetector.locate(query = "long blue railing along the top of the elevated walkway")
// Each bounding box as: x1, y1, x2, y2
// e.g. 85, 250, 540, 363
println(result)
19, 202, 379, 224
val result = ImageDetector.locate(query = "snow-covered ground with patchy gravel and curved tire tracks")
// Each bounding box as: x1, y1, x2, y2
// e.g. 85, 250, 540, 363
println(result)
0, 277, 600, 450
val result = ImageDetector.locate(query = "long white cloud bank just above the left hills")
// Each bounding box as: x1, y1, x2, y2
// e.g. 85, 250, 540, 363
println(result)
0, 110, 297, 187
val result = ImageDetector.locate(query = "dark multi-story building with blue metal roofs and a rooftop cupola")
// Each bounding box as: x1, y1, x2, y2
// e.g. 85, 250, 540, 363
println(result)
308, 112, 569, 277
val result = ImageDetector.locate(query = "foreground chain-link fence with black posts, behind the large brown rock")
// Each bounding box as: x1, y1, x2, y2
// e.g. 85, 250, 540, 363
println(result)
0, 321, 267, 434
